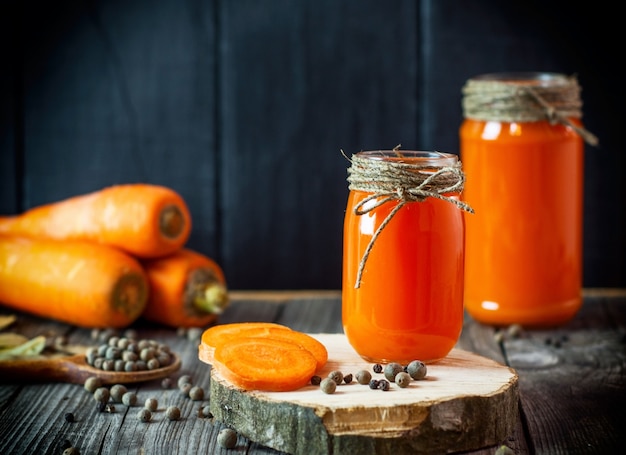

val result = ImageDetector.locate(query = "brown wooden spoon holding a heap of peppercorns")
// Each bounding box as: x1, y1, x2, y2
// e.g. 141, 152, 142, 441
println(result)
0, 353, 181, 384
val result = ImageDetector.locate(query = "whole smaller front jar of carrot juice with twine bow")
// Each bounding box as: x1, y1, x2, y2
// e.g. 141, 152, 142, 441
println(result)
342, 149, 471, 364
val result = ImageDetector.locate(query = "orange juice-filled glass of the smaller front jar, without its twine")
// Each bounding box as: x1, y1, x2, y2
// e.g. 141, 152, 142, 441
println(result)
342, 152, 464, 364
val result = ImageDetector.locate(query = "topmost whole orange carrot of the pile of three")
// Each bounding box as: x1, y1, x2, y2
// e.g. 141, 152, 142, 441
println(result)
0, 184, 191, 258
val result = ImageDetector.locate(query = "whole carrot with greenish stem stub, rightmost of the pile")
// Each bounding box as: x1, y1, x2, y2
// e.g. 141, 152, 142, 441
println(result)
142, 248, 229, 327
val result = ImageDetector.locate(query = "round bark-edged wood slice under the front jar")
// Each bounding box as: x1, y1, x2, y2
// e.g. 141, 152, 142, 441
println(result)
210, 334, 518, 455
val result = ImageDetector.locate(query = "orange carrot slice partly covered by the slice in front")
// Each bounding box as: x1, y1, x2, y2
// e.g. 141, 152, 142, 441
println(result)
198, 322, 328, 369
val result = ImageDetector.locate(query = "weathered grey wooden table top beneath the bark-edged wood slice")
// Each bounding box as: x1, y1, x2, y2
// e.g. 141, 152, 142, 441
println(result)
0, 289, 626, 455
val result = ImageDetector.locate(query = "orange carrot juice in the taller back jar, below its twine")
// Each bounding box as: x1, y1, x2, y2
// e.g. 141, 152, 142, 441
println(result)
461, 120, 583, 326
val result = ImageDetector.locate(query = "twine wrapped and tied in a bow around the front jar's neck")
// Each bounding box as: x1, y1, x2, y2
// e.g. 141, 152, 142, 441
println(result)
342, 149, 474, 289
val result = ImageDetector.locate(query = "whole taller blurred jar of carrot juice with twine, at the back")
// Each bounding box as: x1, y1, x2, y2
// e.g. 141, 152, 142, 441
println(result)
460, 73, 596, 327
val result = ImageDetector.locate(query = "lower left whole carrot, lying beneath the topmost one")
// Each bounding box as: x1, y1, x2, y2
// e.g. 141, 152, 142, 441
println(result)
0, 235, 148, 328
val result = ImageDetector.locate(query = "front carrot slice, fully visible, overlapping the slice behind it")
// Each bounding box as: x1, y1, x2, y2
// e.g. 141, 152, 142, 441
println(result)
213, 337, 317, 392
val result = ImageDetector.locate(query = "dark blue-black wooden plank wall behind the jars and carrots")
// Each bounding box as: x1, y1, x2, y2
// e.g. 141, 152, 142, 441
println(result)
0, 0, 626, 289
